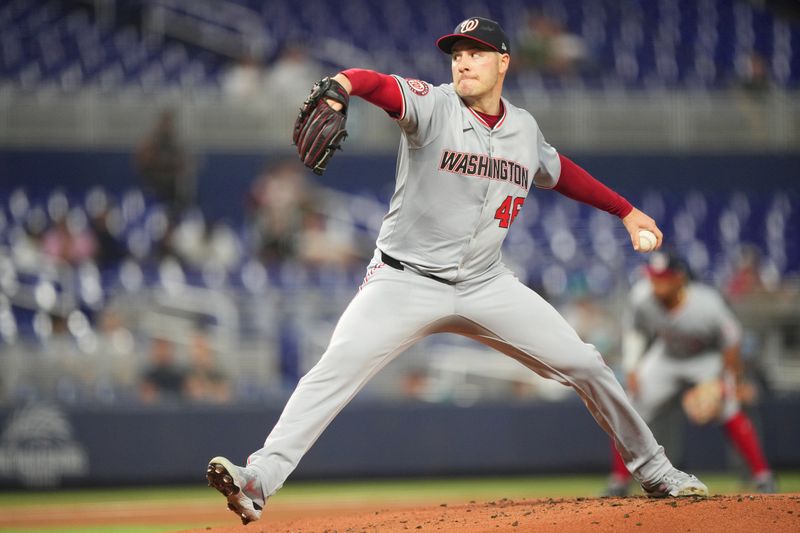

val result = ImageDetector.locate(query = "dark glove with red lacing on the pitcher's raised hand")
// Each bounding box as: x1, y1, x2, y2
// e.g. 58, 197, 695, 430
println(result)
292, 78, 350, 176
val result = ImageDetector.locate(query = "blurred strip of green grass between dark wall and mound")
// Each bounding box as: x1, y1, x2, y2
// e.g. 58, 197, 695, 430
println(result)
0, 472, 800, 533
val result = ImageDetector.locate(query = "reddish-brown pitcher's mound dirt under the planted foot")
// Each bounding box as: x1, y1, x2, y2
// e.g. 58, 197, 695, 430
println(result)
189, 494, 800, 533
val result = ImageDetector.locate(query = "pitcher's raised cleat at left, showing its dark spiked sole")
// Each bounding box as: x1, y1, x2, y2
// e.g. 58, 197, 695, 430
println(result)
206, 457, 264, 525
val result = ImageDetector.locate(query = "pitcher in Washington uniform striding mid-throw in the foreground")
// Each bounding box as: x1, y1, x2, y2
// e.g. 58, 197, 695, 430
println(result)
207, 17, 708, 523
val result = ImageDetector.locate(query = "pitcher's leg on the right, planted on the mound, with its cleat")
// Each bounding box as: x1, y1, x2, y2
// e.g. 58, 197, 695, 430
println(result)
456, 275, 707, 496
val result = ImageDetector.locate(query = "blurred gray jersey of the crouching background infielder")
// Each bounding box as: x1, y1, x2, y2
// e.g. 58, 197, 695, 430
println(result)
629, 282, 742, 359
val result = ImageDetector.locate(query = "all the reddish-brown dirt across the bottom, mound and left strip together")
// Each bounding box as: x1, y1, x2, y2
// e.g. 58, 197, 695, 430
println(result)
0, 493, 800, 533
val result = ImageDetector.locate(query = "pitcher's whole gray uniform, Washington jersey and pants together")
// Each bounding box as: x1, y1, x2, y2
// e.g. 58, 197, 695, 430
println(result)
239, 77, 672, 502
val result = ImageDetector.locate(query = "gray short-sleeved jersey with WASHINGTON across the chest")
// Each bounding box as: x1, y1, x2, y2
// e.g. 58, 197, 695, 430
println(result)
377, 76, 561, 281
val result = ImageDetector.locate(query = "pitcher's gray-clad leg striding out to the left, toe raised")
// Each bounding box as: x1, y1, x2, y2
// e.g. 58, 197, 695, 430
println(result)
209, 266, 453, 520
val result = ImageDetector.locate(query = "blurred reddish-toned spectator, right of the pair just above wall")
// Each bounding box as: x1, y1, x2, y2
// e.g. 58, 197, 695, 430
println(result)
185, 330, 231, 403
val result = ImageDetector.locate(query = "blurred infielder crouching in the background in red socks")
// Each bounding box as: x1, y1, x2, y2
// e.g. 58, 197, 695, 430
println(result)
606, 252, 776, 496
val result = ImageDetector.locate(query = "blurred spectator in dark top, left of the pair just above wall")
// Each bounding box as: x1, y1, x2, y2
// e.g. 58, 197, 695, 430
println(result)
139, 338, 186, 404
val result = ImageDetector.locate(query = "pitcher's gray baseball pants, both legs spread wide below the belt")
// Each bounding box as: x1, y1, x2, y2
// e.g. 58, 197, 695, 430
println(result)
248, 253, 672, 497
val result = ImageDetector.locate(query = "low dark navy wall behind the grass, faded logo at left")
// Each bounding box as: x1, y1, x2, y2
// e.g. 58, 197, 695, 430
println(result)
0, 398, 800, 488
